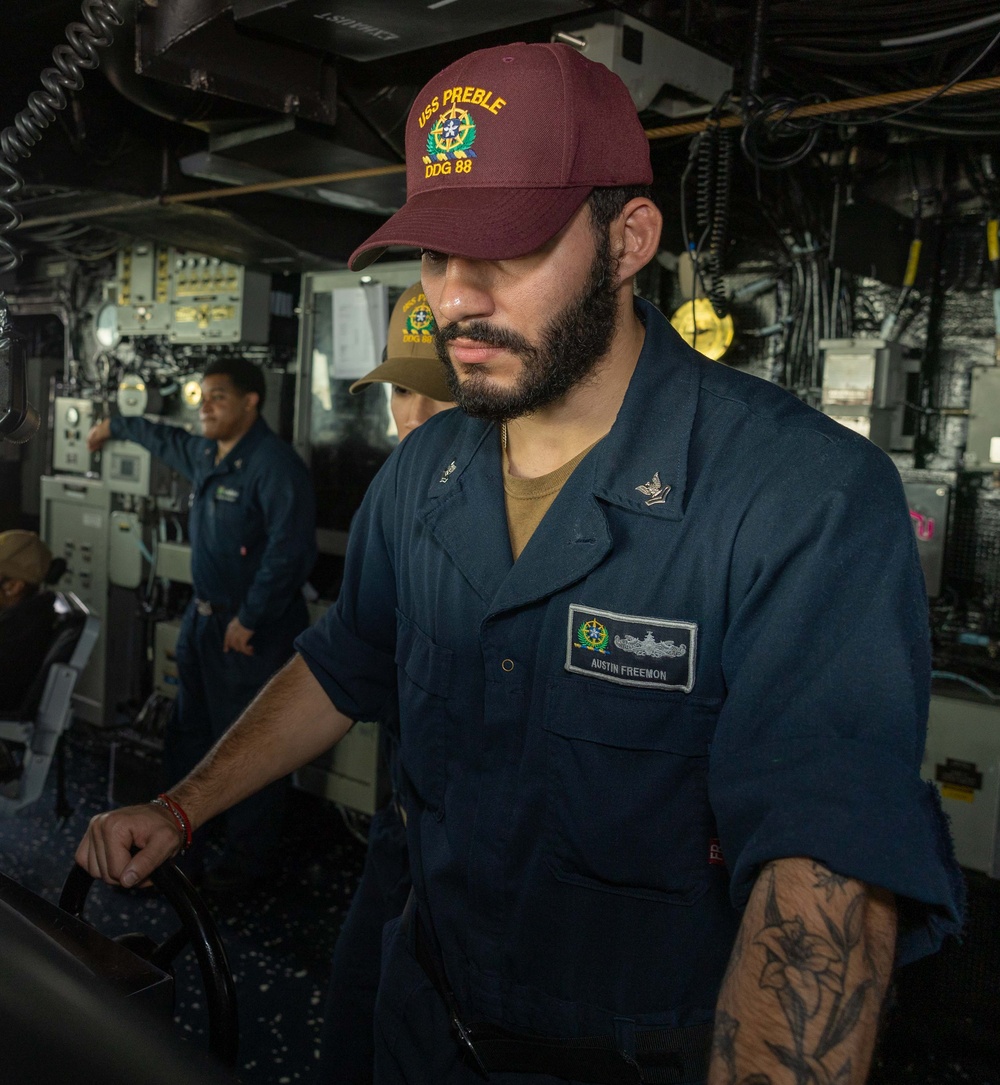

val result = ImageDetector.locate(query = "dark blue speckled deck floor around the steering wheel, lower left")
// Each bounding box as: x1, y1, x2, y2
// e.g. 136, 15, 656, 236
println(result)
0, 732, 364, 1085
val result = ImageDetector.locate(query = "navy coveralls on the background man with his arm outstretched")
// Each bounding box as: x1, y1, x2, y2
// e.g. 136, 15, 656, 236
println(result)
111, 417, 316, 877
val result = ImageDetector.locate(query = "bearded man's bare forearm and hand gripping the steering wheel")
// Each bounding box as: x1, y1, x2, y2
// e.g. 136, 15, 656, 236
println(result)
76, 655, 351, 886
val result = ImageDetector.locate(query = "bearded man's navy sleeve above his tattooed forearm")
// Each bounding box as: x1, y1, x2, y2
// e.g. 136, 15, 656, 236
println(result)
709, 442, 964, 963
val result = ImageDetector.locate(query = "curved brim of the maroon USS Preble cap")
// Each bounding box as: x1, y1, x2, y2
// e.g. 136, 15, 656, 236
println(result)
347, 187, 592, 271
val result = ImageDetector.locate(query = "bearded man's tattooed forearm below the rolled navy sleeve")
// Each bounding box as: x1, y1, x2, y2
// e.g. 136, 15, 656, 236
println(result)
708, 858, 896, 1085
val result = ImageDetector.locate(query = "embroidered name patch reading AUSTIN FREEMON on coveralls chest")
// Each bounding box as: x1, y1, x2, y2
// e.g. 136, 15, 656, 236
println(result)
566, 603, 697, 693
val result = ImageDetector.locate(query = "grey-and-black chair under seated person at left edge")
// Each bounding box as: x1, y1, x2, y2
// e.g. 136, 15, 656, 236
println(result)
0, 591, 101, 816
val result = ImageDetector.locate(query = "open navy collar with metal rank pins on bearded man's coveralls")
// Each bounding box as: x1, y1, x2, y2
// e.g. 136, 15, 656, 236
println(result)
421, 299, 701, 613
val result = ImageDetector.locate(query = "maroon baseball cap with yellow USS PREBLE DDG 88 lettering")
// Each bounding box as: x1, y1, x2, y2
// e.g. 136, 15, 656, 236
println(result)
348, 42, 653, 271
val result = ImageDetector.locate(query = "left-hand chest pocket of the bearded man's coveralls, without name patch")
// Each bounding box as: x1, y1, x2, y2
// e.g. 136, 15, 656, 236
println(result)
396, 610, 454, 810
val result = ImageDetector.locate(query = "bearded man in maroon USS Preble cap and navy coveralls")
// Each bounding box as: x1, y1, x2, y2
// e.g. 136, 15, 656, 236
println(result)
77, 44, 963, 1085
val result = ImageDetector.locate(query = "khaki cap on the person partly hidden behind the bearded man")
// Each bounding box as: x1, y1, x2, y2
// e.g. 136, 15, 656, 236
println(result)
350, 282, 454, 404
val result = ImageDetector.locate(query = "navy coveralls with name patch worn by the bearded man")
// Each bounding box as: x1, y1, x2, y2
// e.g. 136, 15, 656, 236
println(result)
297, 301, 962, 1085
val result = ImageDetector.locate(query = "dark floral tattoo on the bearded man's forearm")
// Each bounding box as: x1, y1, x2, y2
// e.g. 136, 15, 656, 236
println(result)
711, 863, 883, 1085
